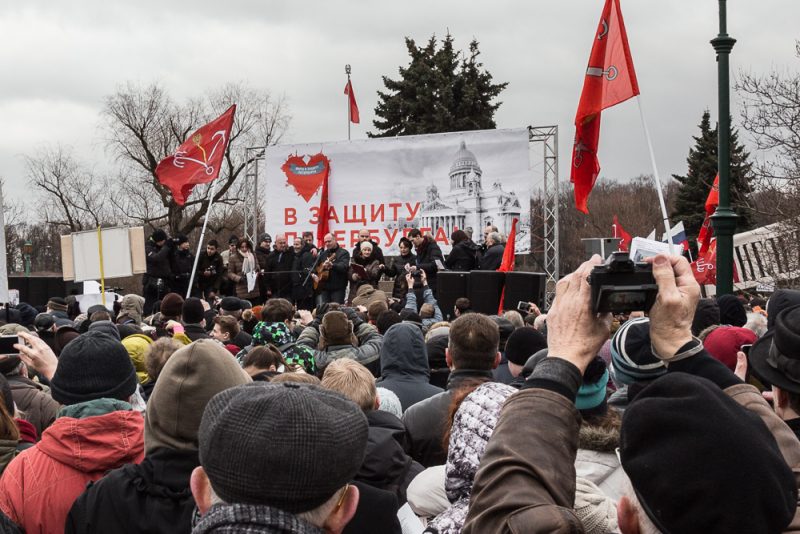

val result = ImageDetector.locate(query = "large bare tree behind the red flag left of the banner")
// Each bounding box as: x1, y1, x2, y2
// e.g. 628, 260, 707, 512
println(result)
103, 83, 290, 234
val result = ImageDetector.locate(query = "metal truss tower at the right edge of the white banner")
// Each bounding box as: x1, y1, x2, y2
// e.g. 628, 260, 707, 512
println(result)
528, 126, 559, 308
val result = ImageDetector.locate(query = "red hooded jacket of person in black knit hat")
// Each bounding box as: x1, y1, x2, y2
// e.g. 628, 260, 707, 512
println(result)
0, 411, 144, 534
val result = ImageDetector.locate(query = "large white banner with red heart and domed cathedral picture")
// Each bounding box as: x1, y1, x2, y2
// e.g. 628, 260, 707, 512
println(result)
265, 128, 533, 255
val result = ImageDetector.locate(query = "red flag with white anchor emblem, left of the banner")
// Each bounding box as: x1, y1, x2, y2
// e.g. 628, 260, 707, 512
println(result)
156, 104, 236, 206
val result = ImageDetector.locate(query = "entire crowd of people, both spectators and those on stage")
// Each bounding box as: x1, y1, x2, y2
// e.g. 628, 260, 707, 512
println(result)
0, 224, 800, 534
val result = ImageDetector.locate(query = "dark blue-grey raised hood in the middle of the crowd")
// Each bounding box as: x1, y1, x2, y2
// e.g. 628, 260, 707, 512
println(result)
381, 323, 431, 382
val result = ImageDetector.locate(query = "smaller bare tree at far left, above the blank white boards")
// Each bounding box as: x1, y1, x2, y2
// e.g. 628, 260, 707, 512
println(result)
25, 145, 114, 232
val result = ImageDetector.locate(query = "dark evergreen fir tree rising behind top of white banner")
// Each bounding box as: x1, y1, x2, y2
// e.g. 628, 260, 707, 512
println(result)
368, 34, 508, 137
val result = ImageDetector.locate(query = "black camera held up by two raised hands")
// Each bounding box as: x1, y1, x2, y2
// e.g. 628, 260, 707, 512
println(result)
589, 252, 658, 313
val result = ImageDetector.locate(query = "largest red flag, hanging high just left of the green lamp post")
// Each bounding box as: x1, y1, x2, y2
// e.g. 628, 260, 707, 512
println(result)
570, 0, 639, 213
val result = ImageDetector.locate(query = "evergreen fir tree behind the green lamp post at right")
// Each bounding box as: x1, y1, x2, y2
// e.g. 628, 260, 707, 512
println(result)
672, 110, 753, 237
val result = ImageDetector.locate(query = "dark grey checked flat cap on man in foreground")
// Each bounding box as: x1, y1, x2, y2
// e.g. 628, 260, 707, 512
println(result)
198, 382, 368, 514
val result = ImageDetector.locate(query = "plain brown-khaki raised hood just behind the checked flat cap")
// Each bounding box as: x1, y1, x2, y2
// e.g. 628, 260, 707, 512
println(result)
144, 339, 251, 454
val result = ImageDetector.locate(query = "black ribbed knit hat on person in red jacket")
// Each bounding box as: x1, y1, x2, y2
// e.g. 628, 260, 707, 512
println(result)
50, 331, 136, 405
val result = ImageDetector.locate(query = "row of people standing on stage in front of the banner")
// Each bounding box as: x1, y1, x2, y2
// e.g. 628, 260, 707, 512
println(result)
142, 225, 505, 314
